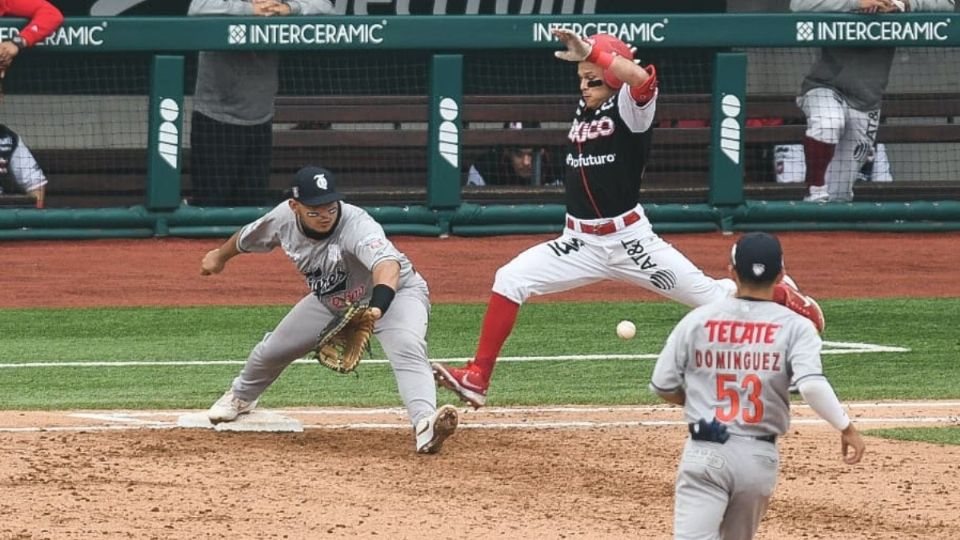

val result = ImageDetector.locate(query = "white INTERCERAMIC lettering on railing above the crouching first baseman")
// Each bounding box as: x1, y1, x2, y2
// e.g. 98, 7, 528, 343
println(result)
227, 20, 387, 45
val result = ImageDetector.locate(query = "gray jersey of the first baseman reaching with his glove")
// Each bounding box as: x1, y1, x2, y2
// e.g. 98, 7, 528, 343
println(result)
237, 201, 423, 311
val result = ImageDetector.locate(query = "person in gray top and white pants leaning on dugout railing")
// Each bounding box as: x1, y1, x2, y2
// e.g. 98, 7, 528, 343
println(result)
790, 0, 955, 202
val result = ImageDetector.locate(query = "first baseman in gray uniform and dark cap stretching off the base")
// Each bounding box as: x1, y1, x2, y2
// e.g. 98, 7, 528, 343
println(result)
202, 166, 457, 454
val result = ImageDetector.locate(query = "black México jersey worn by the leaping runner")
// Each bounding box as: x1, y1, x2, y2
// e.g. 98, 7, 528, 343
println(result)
564, 84, 656, 219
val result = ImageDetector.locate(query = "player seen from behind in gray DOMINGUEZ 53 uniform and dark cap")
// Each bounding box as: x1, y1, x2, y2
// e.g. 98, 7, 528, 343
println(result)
650, 233, 864, 540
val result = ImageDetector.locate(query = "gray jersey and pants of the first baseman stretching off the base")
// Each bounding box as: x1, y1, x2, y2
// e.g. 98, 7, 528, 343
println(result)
223, 202, 437, 425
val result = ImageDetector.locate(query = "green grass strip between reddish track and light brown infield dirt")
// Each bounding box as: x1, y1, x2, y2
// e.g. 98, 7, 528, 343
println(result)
0, 299, 960, 409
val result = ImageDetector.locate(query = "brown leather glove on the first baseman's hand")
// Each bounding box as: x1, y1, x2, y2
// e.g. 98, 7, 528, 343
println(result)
314, 304, 377, 373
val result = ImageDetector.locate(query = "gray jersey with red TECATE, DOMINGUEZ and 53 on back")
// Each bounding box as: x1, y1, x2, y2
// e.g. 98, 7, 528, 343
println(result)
651, 298, 823, 436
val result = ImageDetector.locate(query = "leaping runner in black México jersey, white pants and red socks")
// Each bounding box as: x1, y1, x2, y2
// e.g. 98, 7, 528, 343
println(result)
433, 29, 824, 408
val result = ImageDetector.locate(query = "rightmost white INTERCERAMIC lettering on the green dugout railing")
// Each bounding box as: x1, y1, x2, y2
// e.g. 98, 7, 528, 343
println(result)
797, 17, 952, 43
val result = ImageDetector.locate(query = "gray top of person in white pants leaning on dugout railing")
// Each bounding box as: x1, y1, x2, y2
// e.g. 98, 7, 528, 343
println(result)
790, 0, 955, 112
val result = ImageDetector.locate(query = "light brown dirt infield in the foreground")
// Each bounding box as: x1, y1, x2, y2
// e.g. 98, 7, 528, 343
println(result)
0, 402, 960, 540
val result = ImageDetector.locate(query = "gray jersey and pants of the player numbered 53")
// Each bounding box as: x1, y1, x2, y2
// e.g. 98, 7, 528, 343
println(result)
650, 298, 823, 539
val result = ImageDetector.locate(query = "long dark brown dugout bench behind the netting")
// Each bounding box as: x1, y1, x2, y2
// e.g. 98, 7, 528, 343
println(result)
26, 93, 960, 207
